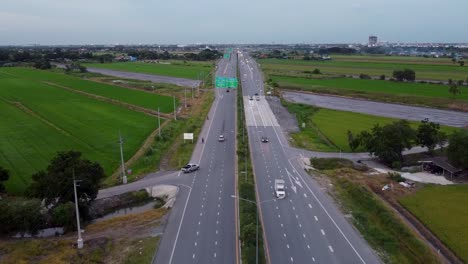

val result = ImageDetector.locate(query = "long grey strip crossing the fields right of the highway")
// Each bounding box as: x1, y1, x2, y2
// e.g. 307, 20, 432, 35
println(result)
283, 91, 468, 127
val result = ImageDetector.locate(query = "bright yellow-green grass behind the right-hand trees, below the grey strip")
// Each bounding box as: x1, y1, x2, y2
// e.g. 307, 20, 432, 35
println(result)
282, 99, 458, 152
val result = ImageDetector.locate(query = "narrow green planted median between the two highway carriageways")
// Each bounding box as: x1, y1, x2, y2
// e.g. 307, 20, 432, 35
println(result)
237, 79, 266, 263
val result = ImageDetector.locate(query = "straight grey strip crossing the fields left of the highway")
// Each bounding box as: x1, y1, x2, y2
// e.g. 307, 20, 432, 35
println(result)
86, 67, 201, 87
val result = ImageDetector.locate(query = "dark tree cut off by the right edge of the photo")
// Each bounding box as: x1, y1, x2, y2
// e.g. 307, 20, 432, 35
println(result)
447, 130, 468, 169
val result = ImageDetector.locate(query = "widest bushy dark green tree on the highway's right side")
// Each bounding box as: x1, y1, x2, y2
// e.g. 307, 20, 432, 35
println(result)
352, 120, 416, 166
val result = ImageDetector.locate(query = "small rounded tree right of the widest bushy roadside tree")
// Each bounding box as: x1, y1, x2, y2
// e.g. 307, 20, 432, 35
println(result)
416, 118, 446, 154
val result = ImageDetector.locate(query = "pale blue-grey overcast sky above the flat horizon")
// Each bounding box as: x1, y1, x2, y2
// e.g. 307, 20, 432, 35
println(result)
0, 0, 468, 45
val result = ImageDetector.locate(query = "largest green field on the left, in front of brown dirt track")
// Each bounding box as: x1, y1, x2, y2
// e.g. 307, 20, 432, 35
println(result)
0, 69, 157, 194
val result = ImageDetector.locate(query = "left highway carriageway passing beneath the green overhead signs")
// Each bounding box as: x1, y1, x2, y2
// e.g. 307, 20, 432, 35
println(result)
154, 56, 238, 264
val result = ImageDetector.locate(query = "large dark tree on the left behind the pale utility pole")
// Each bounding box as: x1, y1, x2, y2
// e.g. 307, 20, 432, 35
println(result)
29, 150, 104, 212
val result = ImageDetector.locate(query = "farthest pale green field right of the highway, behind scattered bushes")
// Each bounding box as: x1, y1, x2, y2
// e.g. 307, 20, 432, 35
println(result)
259, 56, 468, 81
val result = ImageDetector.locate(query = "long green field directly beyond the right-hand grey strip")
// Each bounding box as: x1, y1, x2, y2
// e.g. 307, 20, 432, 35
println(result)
272, 76, 468, 100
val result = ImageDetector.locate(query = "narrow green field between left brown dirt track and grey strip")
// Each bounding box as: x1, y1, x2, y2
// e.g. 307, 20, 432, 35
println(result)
0, 67, 178, 113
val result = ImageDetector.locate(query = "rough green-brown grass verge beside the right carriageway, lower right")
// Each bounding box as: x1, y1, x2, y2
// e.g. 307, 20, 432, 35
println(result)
314, 168, 440, 263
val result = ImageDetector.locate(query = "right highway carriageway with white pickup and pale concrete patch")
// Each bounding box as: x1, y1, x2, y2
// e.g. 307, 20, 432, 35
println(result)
239, 53, 380, 264
